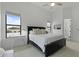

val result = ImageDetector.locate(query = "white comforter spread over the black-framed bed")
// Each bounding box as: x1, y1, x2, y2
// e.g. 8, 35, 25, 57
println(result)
29, 33, 64, 52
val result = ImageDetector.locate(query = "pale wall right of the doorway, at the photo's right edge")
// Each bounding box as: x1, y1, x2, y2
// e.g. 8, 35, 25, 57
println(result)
72, 4, 79, 41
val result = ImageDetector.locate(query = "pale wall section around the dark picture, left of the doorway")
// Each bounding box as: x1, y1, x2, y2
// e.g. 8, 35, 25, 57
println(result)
52, 6, 63, 33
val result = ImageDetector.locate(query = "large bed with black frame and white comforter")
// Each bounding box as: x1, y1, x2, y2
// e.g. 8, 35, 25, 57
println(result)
27, 26, 66, 57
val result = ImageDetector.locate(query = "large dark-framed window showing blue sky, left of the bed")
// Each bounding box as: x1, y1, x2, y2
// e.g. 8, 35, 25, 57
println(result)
5, 13, 21, 37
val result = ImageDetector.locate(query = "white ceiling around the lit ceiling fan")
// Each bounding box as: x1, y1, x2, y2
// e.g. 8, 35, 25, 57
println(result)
32, 2, 79, 11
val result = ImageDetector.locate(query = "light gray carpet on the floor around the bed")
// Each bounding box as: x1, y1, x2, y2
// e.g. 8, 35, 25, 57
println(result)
14, 45, 79, 57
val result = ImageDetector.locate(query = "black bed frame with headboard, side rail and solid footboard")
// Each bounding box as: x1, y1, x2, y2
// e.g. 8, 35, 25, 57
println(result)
27, 26, 66, 57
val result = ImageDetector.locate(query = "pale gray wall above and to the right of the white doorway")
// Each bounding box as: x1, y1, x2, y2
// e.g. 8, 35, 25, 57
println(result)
64, 4, 79, 42
